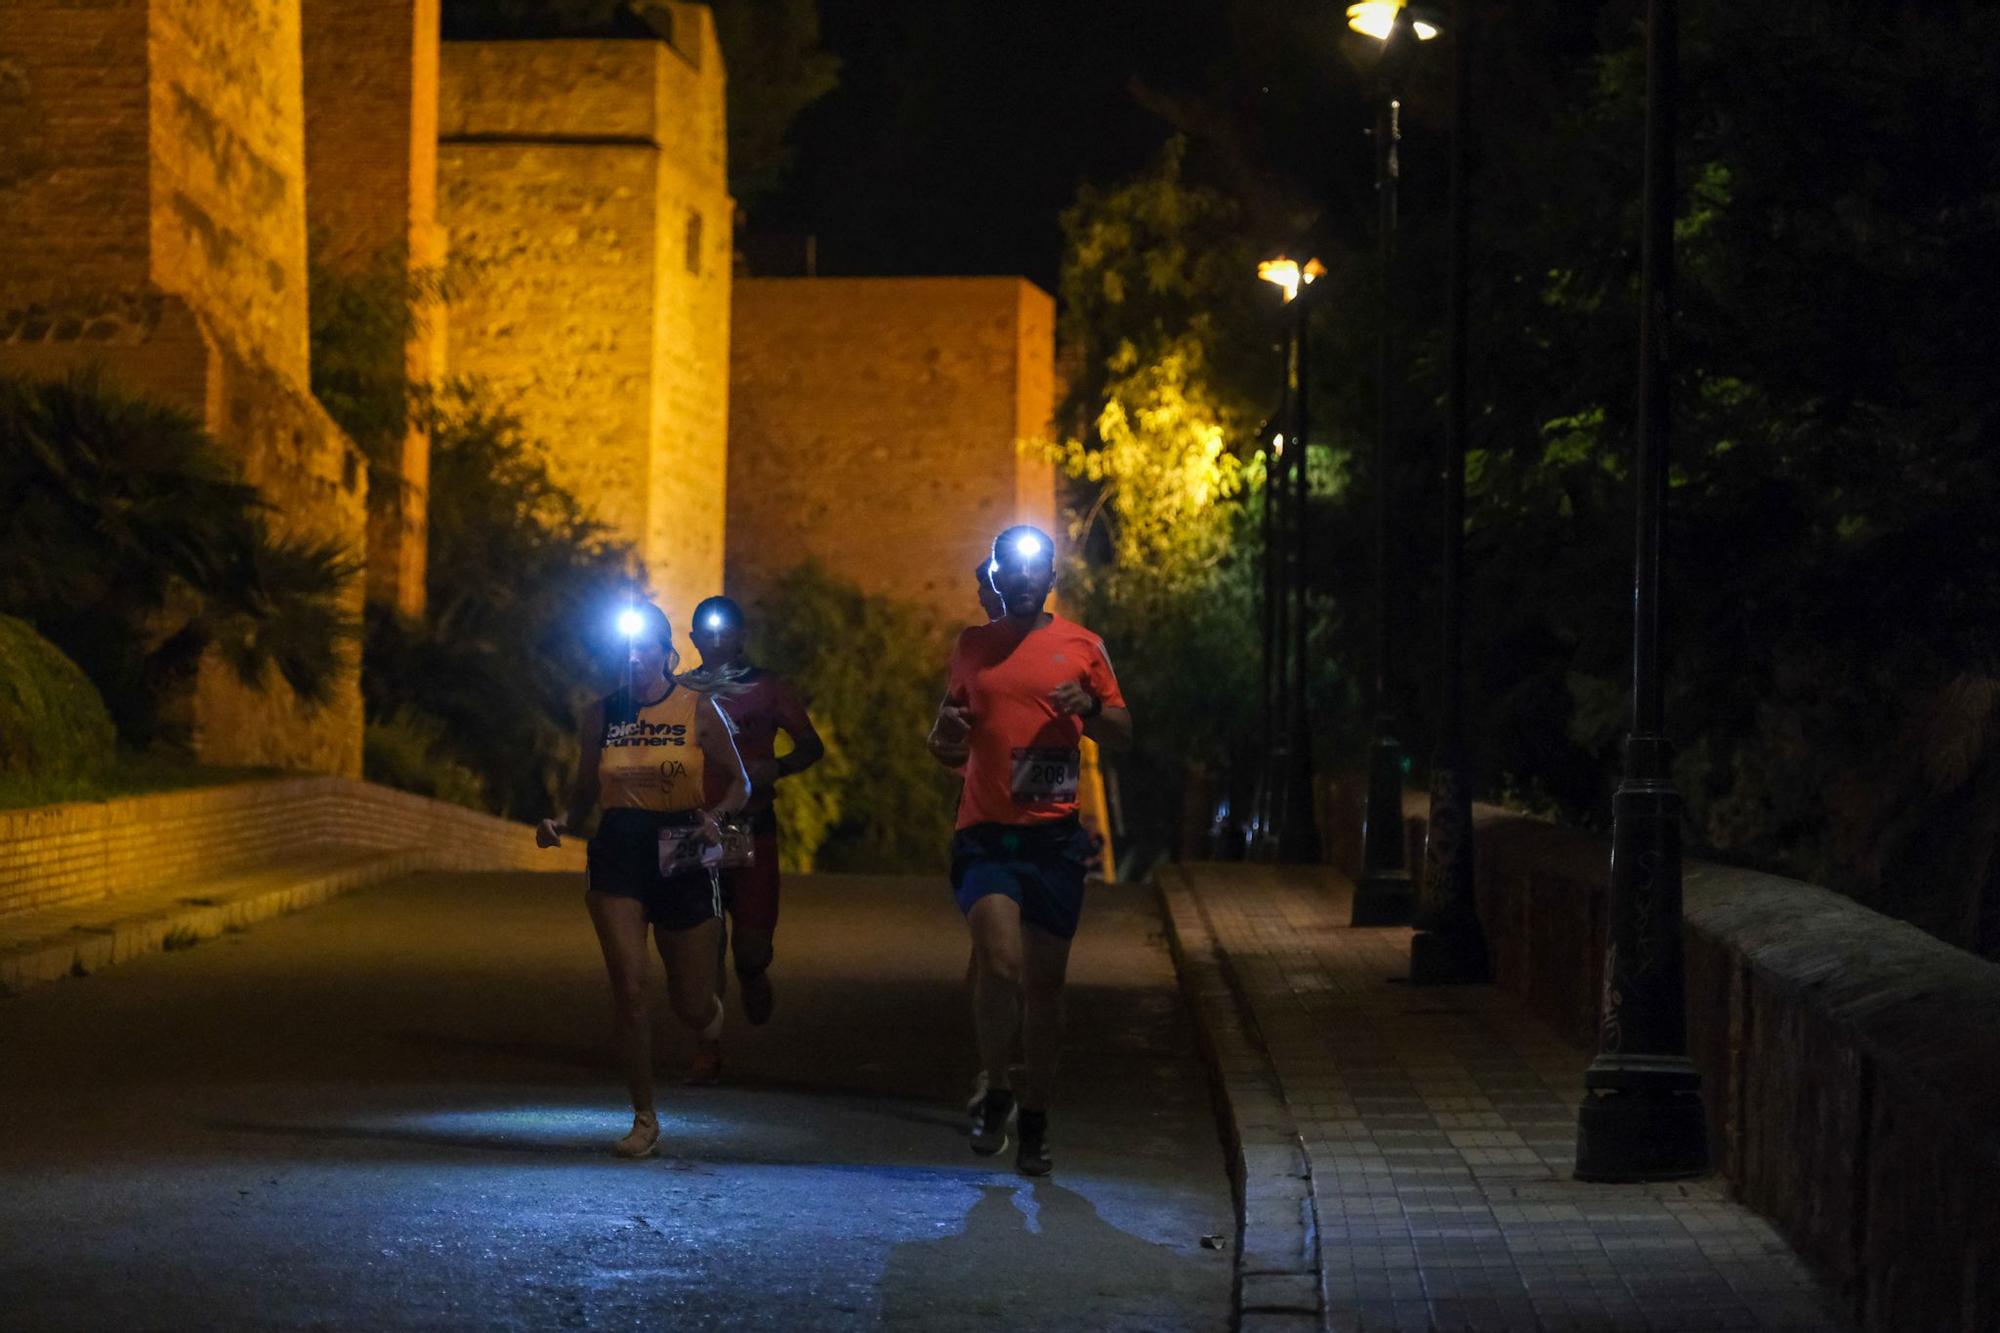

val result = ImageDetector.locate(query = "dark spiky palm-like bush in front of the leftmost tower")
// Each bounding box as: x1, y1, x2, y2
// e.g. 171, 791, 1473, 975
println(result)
0, 372, 358, 747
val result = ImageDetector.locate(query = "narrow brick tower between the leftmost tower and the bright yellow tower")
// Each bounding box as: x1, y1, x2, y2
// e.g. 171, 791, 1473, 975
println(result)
302, 0, 446, 614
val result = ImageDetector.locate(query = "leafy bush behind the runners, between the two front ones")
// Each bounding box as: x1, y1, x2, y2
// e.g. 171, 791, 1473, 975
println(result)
752, 562, 958, 871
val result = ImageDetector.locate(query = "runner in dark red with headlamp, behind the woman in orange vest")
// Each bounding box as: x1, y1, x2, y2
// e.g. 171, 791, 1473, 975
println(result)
688, 596, 826, 1025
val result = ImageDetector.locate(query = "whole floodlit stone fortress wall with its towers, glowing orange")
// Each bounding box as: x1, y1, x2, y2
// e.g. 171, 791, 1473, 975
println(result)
0, 0, 1054, 775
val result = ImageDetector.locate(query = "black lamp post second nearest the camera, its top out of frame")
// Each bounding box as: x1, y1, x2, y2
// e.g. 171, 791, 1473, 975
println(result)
1410, 0, 1492, 985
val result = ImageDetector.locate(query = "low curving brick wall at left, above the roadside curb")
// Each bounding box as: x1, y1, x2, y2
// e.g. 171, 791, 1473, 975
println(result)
0, 777, 582, 913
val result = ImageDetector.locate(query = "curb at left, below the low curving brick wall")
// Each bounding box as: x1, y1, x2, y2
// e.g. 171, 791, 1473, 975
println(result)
0, 851, 434, 995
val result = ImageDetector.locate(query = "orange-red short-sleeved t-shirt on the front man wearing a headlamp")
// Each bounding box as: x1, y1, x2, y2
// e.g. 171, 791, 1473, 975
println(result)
946, 616, 1124, 829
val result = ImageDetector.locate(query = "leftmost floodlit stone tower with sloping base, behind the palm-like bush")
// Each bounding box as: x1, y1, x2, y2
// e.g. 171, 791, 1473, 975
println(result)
0, 0, 366, 773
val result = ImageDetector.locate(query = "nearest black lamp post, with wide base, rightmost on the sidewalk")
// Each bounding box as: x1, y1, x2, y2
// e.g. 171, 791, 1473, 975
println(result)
1576, 0, 1708, 1181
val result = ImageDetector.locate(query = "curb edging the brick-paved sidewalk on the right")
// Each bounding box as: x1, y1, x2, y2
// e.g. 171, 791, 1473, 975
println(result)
1154, 867, 1326, 1333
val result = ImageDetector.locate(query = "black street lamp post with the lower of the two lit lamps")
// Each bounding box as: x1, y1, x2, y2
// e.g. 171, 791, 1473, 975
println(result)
1258, 256, 1326, 863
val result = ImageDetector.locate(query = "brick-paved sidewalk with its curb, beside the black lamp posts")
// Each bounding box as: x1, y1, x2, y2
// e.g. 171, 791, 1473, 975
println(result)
1162, 865, 1842, 1333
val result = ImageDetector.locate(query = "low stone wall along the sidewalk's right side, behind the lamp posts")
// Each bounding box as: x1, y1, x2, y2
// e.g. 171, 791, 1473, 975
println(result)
1330, 797, 2000, 1329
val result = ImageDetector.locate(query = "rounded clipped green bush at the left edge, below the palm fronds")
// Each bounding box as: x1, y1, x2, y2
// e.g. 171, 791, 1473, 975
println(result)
0, 614, 118, 783
